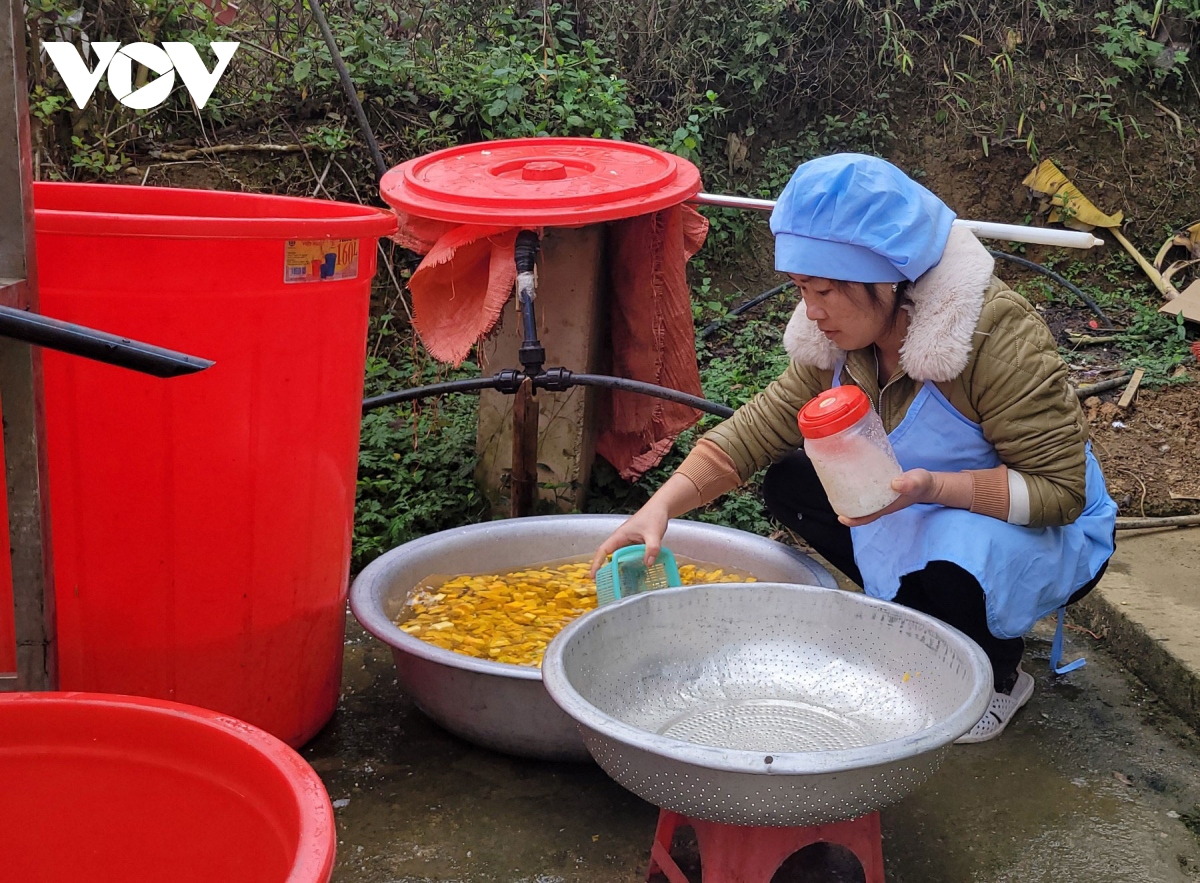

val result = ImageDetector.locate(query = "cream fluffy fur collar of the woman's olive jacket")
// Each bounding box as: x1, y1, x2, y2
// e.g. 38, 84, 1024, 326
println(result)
784, 227, 996, 383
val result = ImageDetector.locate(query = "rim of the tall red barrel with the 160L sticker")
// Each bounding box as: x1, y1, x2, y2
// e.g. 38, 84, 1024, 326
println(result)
34, 181, 397, 240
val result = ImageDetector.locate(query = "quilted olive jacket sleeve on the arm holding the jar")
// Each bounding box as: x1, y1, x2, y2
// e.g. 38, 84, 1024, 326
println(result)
966, 288, 1087, 527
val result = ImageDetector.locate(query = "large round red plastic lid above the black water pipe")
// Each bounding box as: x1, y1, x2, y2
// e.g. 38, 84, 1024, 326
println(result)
379, 138, 700, 227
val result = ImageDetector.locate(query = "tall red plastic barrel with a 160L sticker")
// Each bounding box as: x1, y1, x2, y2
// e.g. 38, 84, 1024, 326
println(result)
34, 184, 395, 745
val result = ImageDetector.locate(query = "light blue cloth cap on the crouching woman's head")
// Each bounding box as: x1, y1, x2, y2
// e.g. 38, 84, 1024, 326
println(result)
770, 154, 954, 282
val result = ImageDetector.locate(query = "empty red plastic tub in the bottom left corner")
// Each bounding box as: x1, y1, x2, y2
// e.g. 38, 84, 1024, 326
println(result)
0, 693, 335, 883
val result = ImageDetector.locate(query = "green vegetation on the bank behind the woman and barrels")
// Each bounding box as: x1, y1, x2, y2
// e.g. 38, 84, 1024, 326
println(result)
25, 0, 1200, 566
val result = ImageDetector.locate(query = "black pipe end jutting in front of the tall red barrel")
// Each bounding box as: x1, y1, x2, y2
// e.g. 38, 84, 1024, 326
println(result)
0, 306, 215, 377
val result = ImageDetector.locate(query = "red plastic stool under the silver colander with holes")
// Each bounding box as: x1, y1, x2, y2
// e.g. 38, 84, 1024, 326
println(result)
646, 810, 884, 883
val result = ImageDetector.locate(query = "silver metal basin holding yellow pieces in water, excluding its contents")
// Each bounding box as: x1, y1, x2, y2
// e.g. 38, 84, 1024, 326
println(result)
350, 515, 835, 761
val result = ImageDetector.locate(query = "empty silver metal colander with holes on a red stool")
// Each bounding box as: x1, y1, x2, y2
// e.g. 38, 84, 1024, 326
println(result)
542, 583, 991, 825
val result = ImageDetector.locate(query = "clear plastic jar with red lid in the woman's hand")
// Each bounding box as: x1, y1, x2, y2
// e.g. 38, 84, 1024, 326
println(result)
798, 386, 904, 518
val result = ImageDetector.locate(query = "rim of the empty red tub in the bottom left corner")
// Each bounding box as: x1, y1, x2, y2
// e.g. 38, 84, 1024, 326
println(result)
0, 691, 337, 882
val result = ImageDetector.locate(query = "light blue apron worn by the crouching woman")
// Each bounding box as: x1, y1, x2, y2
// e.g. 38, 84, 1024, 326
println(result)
834, 361, 1117, 671
